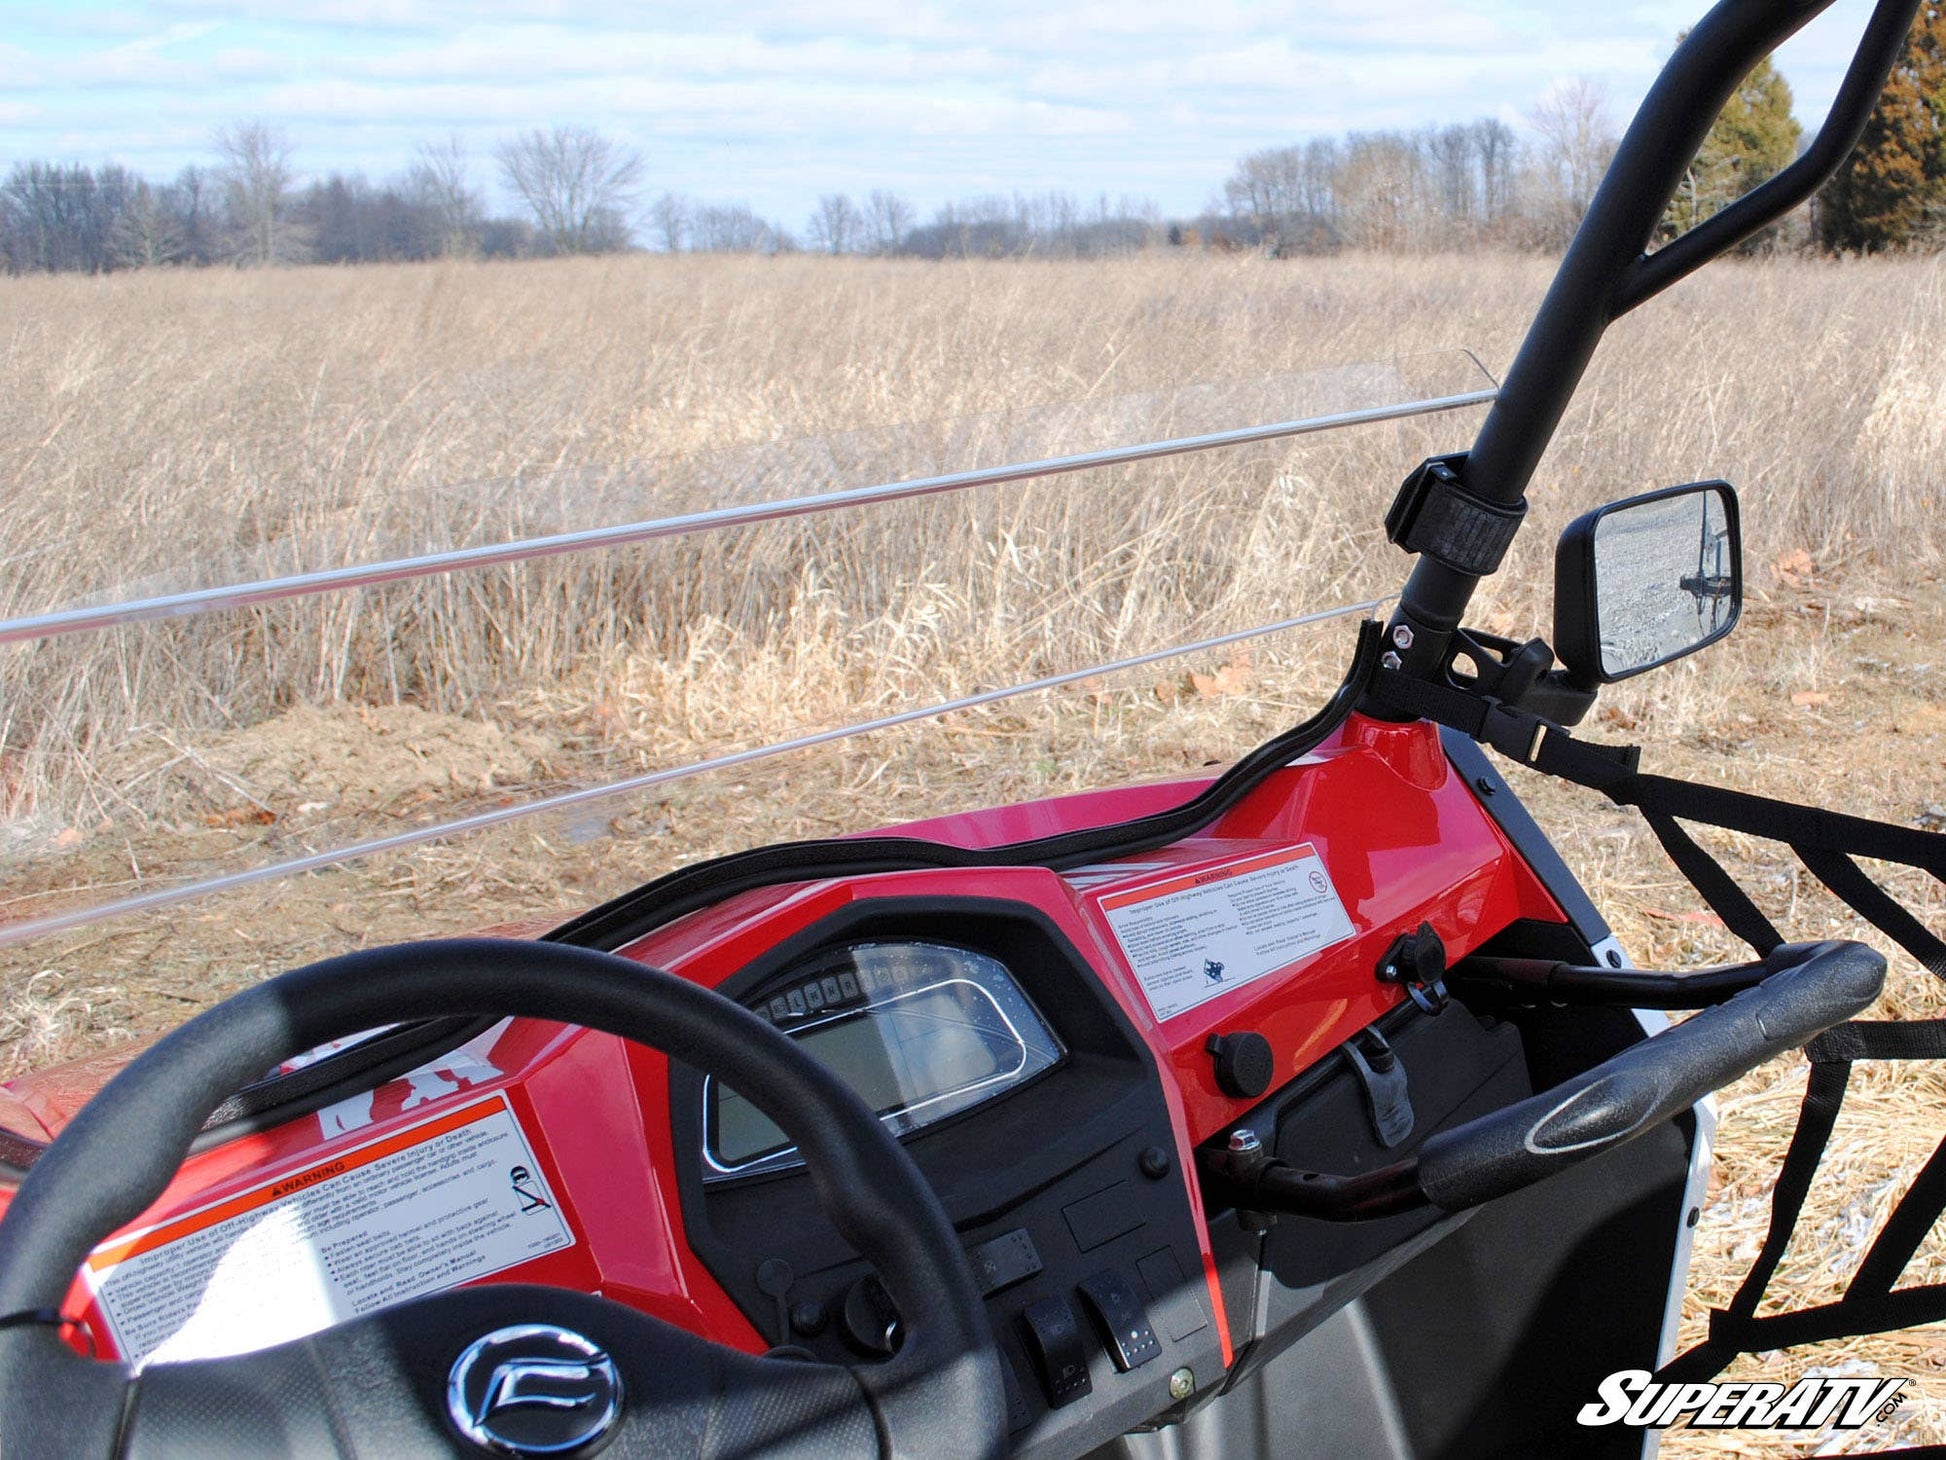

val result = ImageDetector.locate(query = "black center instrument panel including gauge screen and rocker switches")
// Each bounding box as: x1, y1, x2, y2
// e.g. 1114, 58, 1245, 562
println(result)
669, 897, 1228, 1454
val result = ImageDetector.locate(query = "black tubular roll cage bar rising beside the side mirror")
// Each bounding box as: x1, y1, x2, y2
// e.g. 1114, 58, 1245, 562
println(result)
1387, 0, 1921, 683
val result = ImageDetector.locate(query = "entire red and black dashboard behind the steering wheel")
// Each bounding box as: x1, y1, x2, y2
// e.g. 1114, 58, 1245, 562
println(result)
0, 722, 1626, 1456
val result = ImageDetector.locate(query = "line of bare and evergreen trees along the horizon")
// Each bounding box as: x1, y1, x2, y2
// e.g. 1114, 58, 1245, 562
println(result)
0, 19, 1946, 273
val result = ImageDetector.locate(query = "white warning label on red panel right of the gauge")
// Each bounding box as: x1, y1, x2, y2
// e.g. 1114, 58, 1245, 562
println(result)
1101, 841, 1352, 1018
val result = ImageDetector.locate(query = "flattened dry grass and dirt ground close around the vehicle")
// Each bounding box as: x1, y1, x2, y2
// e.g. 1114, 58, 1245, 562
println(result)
0, 561, 1946, 1454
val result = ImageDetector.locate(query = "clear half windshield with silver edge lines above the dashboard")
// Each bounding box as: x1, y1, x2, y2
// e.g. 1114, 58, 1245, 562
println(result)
0, 350, 1495, 1063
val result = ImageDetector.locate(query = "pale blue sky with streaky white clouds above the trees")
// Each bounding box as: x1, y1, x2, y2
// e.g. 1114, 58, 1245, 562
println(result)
0, 0, 1866, 226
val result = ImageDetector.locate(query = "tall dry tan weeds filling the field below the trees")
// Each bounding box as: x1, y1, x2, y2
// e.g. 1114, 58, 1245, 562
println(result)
0, 255, 1946, 829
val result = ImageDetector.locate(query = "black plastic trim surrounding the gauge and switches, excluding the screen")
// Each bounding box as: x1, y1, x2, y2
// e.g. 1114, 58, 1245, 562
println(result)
669, 894, 1222, 1456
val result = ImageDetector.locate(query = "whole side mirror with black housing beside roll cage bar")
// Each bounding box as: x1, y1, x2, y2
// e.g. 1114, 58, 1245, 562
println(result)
1555, 481, 1744, 689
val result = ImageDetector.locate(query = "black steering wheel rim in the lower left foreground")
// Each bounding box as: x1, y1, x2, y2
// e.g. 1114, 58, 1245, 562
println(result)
0, 938, 1006, 1454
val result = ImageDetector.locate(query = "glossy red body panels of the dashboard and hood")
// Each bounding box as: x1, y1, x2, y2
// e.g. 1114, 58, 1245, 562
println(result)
0, 716, 1565, 1351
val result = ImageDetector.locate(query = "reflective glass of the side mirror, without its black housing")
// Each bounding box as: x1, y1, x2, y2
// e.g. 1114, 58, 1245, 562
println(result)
1594, 485, 1742, 679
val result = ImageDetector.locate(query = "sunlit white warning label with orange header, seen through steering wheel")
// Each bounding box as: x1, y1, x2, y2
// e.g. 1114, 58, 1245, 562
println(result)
84, 1094, 574, 1363
